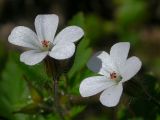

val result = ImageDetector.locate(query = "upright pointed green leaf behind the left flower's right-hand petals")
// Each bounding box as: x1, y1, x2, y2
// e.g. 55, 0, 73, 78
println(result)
68, 13, 92, 79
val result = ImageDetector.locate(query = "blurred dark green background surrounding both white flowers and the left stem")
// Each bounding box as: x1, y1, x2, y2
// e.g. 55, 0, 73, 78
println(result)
0, 0, 160, 120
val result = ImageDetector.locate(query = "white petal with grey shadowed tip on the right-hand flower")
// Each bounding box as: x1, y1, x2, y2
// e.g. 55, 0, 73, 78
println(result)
87, 51, 116, 76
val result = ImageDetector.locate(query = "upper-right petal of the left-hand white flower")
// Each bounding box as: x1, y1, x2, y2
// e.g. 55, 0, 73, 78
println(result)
54, 26, 84, 44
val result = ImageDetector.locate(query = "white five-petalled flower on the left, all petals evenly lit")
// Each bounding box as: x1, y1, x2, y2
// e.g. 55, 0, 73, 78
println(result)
8, 14, 84, 65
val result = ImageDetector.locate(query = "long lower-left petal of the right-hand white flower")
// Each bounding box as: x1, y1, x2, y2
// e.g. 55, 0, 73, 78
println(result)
79, 76, 115, 97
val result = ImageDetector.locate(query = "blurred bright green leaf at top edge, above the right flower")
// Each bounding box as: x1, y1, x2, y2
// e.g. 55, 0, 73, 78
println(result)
116, 0, 146, 27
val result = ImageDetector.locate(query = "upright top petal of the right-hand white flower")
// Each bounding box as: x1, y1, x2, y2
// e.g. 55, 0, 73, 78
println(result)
110, 42, 130, 69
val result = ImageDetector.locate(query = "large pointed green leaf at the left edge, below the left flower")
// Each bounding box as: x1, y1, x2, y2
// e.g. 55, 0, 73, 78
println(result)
0, 51, 28, 120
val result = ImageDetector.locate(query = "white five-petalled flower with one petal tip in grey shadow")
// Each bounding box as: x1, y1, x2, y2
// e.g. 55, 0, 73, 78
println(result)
79, 42, 142, 107
